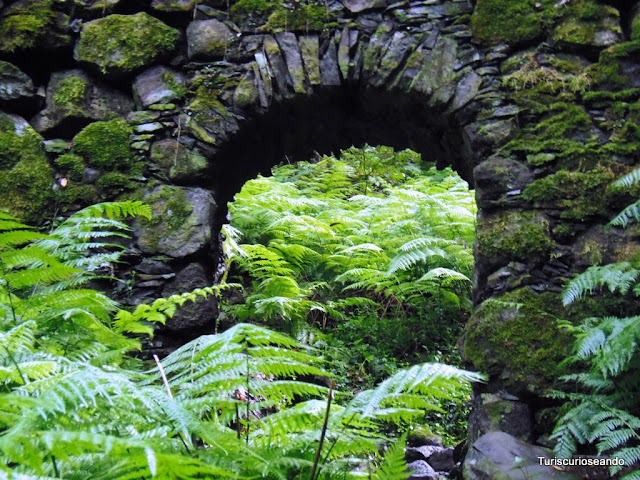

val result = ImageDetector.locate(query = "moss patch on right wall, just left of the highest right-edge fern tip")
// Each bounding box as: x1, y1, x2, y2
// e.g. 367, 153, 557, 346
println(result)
522, 169, 614, 221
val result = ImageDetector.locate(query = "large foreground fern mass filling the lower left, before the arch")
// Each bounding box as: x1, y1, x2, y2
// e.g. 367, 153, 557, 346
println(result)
0, 199, 481, 480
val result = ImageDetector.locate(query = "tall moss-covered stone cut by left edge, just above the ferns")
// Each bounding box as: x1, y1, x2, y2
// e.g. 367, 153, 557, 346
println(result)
0, 114, 53, 224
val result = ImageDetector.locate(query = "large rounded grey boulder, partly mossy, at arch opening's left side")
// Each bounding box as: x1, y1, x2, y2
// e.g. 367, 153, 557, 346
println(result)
135, 185, 216, 258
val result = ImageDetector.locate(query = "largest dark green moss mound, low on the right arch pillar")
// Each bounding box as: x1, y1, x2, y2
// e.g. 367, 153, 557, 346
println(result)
463, 288, 576, 393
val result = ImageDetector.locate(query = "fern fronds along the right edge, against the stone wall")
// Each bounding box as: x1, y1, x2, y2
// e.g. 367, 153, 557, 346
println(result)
554, 170, 640, 480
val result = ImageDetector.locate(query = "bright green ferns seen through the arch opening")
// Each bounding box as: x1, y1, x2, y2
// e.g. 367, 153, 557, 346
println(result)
225, 147, 476, 375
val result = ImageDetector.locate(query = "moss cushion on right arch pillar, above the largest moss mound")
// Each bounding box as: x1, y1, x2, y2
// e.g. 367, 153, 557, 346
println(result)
477, 212, 555, 260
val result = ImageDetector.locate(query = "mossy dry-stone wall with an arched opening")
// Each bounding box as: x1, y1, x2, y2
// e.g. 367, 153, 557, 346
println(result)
0, 0, 640, 454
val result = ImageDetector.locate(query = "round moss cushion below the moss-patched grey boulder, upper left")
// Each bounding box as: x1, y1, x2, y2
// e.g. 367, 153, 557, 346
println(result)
73, 118, 133, 170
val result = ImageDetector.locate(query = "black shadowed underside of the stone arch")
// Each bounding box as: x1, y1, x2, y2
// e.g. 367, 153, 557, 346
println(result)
211, 86, 473, 229
